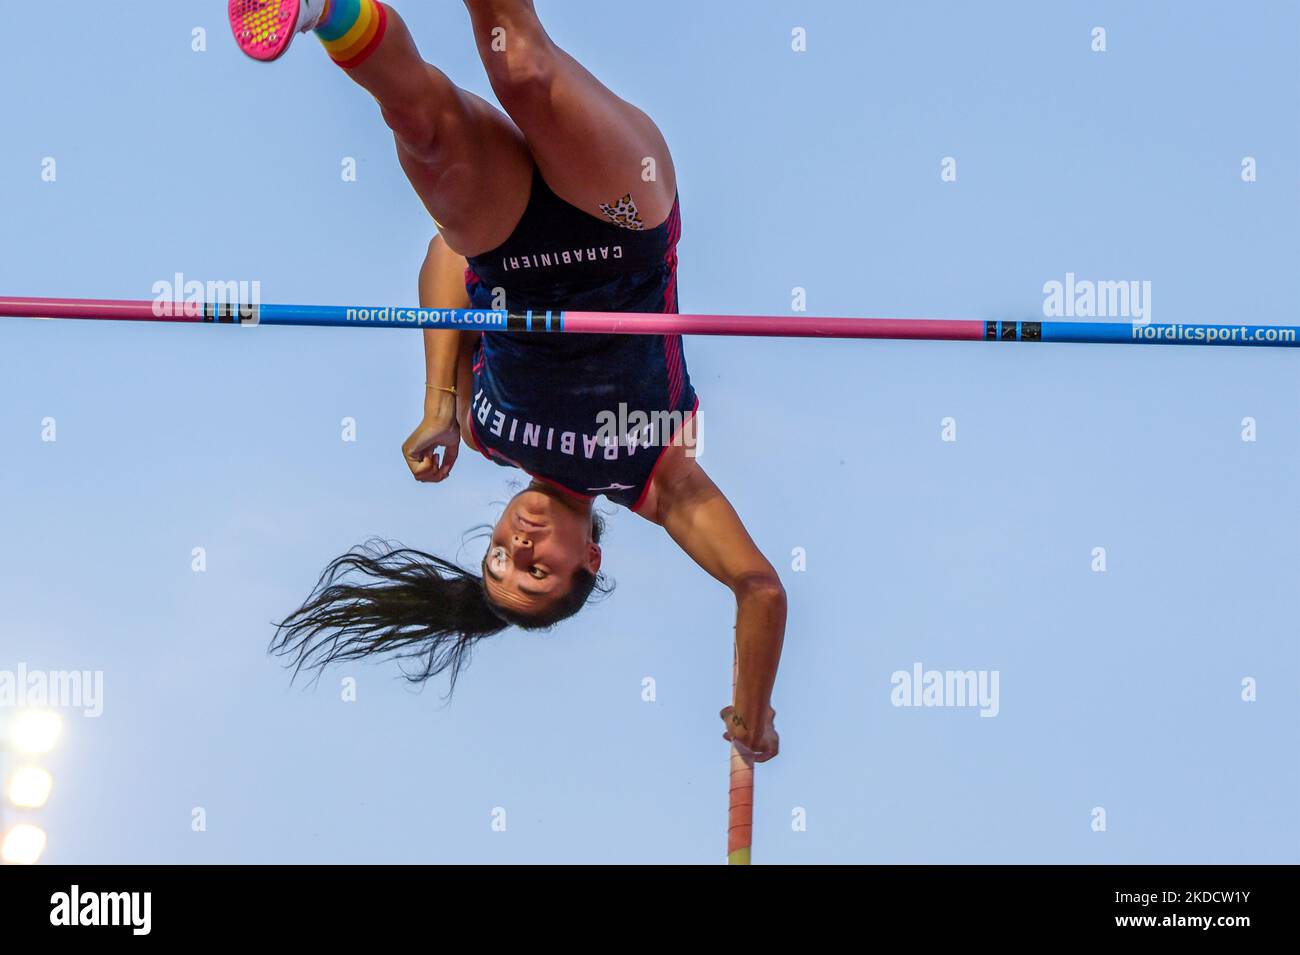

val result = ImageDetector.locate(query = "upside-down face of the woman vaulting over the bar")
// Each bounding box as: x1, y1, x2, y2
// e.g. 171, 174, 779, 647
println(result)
484, 485, 601, 613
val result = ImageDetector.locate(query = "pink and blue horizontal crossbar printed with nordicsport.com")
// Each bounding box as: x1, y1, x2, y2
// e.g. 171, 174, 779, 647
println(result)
0, 298, 1300, 348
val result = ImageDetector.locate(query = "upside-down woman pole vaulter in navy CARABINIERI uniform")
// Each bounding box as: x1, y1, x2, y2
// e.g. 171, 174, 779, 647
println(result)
229, 0, 787, 761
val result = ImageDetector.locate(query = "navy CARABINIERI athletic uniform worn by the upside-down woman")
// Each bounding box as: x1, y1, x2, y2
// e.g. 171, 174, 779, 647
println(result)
465, 170, 697, 509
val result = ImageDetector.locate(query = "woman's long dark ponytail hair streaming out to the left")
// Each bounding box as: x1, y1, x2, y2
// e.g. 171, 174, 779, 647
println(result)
270, 515, 611, 694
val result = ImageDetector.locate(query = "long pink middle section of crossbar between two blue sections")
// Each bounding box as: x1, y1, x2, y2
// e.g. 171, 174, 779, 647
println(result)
564, 312, 984, 342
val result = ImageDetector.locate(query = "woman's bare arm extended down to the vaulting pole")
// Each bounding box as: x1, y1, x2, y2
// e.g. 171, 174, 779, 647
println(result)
640, 446, 785, 763
